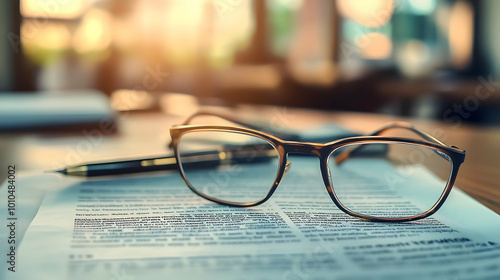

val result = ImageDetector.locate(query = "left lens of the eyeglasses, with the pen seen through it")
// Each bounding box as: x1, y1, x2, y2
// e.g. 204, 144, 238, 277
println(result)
178, 131, 280, 203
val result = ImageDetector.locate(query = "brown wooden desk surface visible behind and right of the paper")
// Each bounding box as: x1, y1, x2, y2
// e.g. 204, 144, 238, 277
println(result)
0, 107, 500, 214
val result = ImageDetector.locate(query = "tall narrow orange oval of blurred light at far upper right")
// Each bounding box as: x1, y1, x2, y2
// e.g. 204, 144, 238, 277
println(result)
449, 1, 474, 68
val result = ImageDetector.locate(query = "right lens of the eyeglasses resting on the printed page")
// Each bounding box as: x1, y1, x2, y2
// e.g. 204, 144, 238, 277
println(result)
329, 142, 452, 218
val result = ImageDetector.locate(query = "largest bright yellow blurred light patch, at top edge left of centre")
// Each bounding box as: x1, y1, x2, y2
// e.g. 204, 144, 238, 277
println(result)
127, 0, 253, 67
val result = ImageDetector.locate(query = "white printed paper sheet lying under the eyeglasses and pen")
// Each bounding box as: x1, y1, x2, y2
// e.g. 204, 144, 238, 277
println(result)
0, 157, 500, 280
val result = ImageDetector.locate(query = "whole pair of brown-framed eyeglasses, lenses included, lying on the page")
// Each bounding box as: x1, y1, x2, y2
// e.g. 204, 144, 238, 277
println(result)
170, 113, 465, 222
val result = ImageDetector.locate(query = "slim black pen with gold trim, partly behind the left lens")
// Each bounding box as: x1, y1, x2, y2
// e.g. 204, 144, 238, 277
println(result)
53, 145, 277, 177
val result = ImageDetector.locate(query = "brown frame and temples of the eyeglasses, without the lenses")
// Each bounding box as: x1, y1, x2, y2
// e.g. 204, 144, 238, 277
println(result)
169, 113, 465, 222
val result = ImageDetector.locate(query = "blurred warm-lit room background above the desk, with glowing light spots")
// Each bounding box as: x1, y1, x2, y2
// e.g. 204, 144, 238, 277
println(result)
0, 0, 500, 125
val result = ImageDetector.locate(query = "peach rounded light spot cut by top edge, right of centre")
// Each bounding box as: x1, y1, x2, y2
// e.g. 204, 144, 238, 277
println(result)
337, 0, 394, 27
